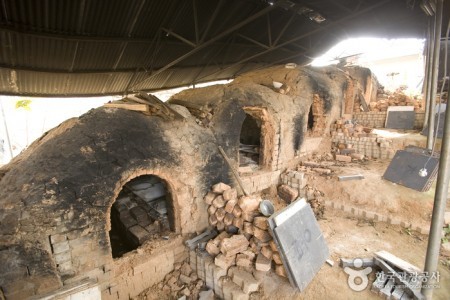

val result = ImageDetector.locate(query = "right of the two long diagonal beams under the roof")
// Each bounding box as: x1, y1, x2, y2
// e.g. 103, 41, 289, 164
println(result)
197, 0, 391, 79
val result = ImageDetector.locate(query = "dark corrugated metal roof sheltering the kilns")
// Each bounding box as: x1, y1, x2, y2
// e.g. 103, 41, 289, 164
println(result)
0, 0, 436, 96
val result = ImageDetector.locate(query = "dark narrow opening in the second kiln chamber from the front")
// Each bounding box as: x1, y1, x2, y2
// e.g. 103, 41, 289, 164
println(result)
239, 114, 261, 167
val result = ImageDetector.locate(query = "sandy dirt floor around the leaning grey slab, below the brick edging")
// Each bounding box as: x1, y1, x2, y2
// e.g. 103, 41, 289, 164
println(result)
259, 210, 450, 299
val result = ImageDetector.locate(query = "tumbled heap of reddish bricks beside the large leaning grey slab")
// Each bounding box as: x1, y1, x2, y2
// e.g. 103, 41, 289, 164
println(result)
204, 183, 287, 277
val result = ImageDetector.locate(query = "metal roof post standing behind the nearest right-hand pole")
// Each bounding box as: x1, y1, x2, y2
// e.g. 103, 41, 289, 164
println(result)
427, 0, 444, 150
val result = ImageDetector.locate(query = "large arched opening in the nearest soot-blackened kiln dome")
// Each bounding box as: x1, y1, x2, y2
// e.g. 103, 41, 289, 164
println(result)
109, 175, 175, 258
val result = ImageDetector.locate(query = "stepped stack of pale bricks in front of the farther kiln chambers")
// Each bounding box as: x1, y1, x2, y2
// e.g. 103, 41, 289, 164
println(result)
331, 120, 395, 162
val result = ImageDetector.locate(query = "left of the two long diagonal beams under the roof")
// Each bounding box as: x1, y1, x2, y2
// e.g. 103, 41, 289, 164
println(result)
130, 5, 276, 89
